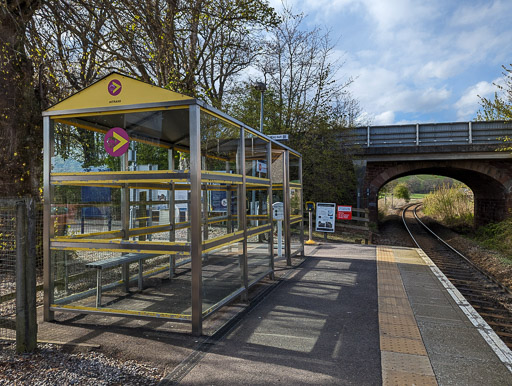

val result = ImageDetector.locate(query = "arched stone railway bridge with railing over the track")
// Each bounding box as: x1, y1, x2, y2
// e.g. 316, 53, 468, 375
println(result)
350, 121, 512, 226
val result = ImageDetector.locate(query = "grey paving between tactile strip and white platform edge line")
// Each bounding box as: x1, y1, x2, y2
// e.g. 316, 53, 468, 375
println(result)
394, 249, 512, 385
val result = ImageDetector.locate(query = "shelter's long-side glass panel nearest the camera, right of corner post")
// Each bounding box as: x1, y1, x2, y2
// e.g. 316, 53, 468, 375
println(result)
197, 110, 245, 316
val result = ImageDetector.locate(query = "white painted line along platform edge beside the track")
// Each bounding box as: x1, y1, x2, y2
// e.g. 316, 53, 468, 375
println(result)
416, 248, 512, 373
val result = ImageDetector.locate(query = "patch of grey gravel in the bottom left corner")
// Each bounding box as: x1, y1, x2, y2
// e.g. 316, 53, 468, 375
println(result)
0, 342, 164, 385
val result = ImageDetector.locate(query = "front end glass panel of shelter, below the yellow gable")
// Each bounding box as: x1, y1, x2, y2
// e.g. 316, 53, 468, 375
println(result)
50, 108, 196, 319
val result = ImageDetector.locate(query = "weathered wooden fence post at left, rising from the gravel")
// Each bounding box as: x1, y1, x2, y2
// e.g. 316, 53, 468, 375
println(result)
16, 200, 37, 353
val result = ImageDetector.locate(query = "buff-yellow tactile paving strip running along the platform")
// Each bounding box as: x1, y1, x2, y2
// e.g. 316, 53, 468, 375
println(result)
377, 247, 437, 386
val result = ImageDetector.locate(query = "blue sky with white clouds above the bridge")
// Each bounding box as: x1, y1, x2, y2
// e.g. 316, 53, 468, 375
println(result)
270, 0, 512, 124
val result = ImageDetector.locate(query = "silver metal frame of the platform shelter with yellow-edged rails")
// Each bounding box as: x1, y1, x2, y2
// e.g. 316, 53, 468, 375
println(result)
43, 73, 304, 335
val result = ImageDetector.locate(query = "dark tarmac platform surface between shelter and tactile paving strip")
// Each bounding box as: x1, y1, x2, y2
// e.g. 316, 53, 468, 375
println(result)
176, 244, 382, 385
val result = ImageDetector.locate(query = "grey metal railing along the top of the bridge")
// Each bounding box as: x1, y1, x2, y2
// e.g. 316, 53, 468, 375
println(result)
349, 121, 512, 147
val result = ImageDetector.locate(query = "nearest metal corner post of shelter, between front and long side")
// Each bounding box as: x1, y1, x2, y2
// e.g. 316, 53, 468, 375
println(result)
189, 104, 203, 335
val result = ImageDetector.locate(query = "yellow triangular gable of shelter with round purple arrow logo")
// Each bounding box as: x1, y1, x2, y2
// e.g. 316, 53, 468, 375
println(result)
46, 72, 193, 112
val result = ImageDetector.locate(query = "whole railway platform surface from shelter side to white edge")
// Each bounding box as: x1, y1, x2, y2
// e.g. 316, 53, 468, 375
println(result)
162, 243, 512, 385
